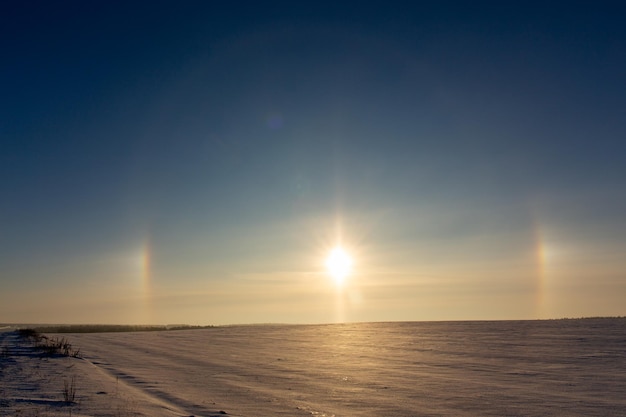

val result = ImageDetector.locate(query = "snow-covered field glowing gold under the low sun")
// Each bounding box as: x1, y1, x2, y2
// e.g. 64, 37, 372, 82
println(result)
0, 319, 626, 417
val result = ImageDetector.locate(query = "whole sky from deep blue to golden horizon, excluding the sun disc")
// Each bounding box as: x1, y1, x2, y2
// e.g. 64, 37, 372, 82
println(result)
0, 0, 626, 324
